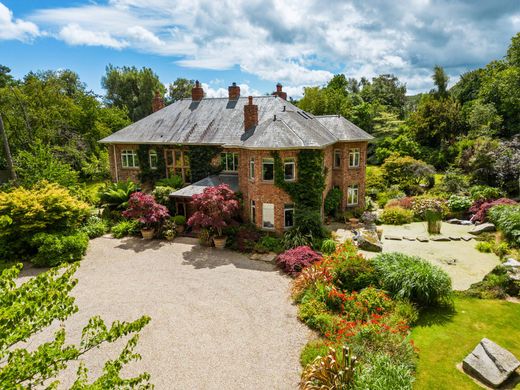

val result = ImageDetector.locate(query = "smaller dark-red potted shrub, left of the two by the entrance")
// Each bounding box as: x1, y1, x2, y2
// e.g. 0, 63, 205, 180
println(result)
123, 192, 169, 240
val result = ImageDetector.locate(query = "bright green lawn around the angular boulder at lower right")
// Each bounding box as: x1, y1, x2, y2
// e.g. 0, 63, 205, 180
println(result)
412, 297, 520, 390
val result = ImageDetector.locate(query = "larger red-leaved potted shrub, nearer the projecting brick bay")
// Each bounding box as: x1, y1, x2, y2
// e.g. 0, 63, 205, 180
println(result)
188, 184, 239, 249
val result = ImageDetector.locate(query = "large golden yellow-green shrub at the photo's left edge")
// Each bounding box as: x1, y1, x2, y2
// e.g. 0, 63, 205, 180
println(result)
0, 182, 89, 260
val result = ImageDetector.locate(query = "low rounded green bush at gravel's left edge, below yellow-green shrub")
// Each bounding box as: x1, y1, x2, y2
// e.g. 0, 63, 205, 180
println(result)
31, 232, 88, 267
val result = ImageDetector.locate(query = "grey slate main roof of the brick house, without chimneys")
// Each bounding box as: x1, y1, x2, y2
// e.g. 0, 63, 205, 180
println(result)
100, 96, 373, 149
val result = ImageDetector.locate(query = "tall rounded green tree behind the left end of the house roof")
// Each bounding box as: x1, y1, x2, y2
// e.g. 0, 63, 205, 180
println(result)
101, 65, 166, 122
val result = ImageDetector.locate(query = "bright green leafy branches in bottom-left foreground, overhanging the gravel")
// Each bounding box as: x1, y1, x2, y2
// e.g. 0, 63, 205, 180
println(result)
0, 263, 151, 389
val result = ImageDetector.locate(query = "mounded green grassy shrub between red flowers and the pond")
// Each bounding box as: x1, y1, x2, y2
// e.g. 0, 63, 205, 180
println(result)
372, 252, 451, 306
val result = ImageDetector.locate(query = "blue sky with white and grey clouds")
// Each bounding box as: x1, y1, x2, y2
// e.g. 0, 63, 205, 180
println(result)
0, 0, 520, 98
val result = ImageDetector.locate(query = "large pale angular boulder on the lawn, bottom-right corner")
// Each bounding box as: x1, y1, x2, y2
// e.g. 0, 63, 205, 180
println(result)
462, 338, 520, 388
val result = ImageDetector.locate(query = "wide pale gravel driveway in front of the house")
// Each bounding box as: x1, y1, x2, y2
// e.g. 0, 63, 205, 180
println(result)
22, 237, 309, 389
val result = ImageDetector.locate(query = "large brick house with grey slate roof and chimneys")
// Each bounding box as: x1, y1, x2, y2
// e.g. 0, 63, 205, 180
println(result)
100, 81, 373, 232
